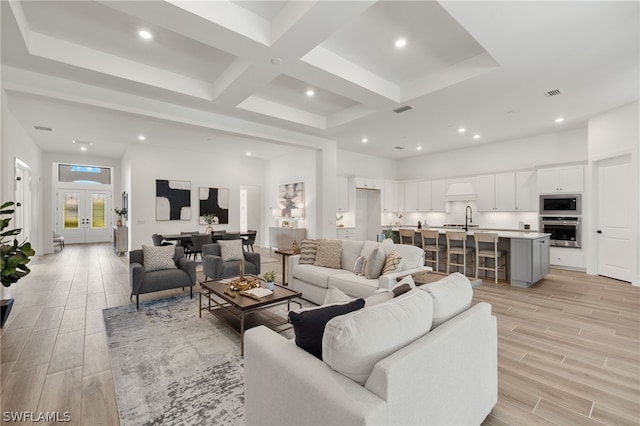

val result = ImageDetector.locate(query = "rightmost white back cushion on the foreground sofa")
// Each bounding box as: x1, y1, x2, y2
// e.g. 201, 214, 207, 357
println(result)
418, 272, 473, 328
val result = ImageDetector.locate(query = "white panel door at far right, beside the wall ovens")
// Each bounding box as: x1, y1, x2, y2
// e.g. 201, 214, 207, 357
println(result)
596, 155, 637, 282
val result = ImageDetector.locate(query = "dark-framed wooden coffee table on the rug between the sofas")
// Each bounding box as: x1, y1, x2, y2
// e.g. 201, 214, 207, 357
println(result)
199, 279, 302, 356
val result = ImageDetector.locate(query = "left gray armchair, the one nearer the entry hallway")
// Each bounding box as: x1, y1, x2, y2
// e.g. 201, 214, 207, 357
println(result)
129, 246, 196, 309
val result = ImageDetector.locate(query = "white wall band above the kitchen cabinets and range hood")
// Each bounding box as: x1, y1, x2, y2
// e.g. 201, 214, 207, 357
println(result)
397, 128, 587, 180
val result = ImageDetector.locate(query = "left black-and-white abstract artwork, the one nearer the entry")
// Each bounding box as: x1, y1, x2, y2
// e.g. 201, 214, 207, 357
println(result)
156, 179, 191, 220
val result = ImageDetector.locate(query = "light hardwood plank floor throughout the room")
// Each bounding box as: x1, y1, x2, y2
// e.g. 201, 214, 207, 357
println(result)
0, 244, 640, 425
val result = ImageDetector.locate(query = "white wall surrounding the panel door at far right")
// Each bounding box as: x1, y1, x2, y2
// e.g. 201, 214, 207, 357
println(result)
583, 102, 640, 286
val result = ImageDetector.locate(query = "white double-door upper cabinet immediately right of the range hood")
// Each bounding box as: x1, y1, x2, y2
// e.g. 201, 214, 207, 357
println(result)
476, 172, 516, 212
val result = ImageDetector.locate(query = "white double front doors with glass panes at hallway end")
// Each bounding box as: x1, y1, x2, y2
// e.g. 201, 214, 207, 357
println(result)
57, 189, 113, 244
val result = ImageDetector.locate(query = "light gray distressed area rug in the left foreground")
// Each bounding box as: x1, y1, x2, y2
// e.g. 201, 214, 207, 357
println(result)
102, 296, 244, 426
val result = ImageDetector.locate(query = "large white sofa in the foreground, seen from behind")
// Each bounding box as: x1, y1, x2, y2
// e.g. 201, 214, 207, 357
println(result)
244, 274, 498, 426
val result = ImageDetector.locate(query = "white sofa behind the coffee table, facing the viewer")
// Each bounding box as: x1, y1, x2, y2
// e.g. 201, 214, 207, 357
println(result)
287, 240, 431, 305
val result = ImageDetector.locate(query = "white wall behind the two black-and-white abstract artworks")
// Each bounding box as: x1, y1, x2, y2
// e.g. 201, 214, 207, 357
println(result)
123, 145, 265, 250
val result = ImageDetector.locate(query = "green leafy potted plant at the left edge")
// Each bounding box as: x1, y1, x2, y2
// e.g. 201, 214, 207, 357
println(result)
0, 201, 36, 327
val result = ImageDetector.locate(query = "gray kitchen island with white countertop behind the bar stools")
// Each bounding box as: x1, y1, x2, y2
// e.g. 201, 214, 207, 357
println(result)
383, 226, 551, 287
